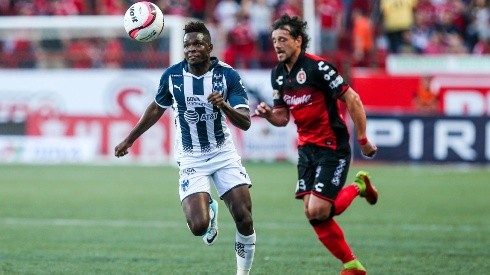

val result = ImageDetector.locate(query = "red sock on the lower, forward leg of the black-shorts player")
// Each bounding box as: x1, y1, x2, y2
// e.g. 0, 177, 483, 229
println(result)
313, 219, 356, 264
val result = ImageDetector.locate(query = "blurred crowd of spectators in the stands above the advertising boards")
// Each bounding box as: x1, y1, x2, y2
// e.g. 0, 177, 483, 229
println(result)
0, 0, 490, 71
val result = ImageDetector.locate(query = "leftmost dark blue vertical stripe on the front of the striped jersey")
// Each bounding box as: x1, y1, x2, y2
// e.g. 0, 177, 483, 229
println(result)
172, 76, 193, 152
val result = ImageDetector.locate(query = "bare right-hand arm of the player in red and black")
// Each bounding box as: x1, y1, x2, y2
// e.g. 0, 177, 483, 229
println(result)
340, 88, 378, 158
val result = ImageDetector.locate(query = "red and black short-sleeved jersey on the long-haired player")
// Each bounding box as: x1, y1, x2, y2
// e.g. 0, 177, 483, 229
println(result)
271, 53, 349, 149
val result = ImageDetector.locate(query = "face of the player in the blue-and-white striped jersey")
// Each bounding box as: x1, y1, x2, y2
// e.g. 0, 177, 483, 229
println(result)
184, 32, 213, 65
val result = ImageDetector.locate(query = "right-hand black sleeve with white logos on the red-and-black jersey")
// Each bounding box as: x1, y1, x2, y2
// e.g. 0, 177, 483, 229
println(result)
312, 60, 349, 98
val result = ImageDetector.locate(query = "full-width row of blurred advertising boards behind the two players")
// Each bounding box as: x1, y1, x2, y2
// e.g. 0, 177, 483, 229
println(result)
0, 69, 490, 164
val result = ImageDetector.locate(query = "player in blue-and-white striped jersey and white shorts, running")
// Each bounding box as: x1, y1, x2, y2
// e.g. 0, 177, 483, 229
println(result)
115, 22, 256, 274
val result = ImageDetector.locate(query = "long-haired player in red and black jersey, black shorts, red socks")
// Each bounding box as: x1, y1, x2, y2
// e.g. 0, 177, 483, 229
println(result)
255, 14, 378, 275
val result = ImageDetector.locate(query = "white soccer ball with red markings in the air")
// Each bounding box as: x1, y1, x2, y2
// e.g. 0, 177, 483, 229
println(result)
124, 1, 164, 42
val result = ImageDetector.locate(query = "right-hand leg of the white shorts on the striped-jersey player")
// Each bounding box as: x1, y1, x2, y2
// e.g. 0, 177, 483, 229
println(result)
212, 161, 252, 198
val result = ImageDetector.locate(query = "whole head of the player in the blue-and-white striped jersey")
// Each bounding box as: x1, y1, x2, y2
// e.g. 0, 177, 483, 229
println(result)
183, 21, 213, 65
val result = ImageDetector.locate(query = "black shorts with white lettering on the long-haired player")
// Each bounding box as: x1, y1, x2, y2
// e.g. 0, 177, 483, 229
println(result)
295, 144, 351, 201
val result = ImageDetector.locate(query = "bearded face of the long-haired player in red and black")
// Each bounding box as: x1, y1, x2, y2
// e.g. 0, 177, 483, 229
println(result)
272, 27, 302, 63
